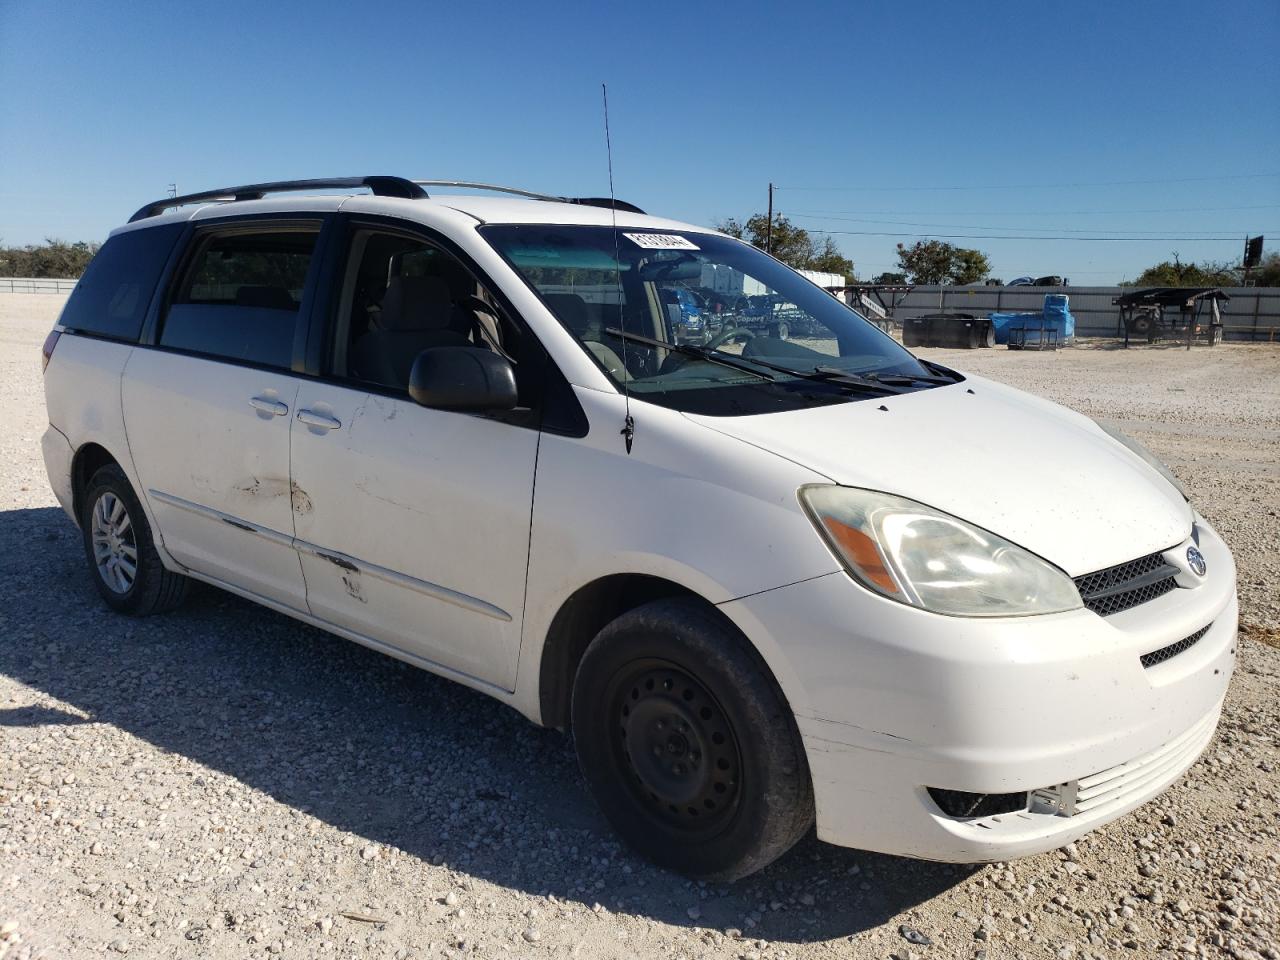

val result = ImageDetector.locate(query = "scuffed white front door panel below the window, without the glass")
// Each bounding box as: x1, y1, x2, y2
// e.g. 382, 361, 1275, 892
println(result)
292, 383, 538, 690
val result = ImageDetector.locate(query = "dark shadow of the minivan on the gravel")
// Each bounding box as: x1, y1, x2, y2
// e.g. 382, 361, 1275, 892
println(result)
0, 507, 975, 942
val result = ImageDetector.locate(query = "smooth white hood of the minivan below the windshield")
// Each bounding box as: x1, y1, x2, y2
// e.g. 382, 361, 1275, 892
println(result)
690, 378, 1192, 577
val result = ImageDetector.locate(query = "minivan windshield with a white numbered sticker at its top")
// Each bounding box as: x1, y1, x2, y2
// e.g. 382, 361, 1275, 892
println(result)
481, 224, 942, 416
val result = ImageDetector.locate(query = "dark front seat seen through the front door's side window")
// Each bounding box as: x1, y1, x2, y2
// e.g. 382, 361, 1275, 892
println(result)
348, 275, 470, 389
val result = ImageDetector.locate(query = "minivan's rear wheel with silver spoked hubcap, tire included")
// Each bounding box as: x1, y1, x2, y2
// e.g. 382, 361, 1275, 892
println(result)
81, 463, 191, 617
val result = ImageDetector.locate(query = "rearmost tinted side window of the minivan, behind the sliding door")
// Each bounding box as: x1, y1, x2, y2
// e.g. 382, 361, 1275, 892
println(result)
59, 223, 184, 342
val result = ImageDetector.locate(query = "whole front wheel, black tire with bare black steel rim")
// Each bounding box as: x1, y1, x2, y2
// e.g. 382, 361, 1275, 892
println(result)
572, 599, 814, 881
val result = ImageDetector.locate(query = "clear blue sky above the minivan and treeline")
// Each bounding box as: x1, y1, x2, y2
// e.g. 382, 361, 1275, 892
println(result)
0, 0, 1280, 284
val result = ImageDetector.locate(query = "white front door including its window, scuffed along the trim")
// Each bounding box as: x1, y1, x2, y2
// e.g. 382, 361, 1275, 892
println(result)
292, 229, 538, 690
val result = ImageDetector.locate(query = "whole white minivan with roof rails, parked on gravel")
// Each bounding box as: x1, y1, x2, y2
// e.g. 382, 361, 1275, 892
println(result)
44, 177, 1236, 879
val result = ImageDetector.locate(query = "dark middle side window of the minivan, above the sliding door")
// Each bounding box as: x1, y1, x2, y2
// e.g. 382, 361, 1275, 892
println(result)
160, 225, 320, 369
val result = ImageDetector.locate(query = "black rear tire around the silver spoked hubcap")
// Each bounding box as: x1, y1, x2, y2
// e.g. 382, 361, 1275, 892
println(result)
81, 463, 191, 617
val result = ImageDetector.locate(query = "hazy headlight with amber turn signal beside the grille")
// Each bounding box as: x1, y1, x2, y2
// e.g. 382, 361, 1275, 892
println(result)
800, 485, 1082, 617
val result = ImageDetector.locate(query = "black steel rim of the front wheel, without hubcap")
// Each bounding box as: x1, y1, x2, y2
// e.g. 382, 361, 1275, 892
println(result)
613, 660, 741, 831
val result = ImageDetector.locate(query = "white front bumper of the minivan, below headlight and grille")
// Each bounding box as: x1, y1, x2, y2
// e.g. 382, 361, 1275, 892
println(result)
722, 521, 1238, 861
